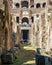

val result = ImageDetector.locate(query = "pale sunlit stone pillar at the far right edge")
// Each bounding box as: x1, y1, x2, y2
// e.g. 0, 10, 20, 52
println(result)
48, 13, 52, 49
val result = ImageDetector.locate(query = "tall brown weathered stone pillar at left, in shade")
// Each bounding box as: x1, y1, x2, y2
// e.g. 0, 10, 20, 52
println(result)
4, 0, 13, 50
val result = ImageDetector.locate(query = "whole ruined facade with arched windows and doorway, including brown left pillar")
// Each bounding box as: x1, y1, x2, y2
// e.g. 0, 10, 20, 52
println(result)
0, 0, 52, 51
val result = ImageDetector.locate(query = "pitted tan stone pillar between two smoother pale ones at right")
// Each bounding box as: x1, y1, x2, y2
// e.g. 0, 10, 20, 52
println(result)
41, 12, 46, 49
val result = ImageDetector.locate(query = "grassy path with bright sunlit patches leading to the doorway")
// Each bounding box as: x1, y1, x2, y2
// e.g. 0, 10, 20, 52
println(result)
2, 45, 35, 65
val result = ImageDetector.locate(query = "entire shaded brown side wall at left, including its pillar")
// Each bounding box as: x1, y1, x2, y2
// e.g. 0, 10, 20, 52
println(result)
0, 0, 13, 55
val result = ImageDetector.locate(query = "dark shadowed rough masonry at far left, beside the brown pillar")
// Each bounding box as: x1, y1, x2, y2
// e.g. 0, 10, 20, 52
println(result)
0, 9, 5, 52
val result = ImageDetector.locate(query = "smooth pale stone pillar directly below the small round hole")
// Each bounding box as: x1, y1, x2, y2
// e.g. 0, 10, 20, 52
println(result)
37, 18, 42, 48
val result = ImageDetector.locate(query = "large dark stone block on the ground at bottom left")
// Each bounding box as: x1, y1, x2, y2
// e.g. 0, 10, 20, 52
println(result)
1, 52, 14, 64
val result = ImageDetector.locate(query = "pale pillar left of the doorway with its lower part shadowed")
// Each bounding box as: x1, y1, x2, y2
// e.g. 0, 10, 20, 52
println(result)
12, 15, 17, 45
